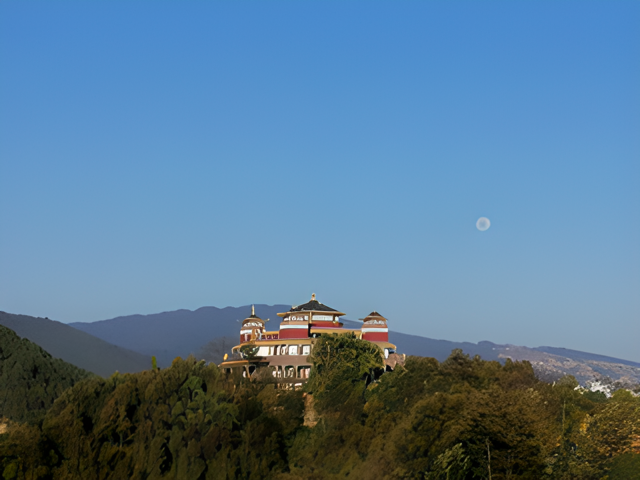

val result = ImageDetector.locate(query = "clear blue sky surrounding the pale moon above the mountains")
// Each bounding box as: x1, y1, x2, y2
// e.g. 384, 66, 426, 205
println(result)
0, 1, 640, 361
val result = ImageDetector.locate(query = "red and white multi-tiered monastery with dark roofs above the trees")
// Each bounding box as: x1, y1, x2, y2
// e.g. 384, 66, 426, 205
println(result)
220, 293, 404, 387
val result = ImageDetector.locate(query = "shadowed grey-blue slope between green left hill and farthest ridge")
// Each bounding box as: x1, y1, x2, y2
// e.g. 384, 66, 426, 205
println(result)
0, 312, 151, 377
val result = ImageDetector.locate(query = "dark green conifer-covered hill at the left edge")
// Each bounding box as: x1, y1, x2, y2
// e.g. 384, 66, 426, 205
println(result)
0, 325, 92, 422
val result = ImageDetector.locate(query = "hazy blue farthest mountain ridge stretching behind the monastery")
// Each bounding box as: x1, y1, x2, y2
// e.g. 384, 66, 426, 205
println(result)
69, 305, 640, 385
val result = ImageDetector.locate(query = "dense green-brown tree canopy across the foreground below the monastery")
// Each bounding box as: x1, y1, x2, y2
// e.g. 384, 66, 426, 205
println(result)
0, 335, 640, 480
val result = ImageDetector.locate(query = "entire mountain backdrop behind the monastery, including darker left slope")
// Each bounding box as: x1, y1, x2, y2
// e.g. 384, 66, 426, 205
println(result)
0, 305, 640, 386
